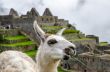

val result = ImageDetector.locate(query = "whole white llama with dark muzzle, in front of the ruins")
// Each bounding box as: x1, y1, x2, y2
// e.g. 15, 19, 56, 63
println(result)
0, 21, 76, 72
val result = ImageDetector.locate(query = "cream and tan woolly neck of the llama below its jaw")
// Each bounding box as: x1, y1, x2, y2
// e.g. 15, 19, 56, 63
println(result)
37, 50, 60, 72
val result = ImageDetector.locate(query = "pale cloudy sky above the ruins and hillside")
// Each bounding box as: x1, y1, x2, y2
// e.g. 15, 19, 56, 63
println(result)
0, 0, 110, 42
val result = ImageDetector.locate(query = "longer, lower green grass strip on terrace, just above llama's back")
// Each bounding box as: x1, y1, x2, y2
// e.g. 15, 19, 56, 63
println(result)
0, 41, 35, 47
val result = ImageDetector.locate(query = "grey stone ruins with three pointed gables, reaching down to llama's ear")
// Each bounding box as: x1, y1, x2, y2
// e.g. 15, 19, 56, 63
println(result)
0, 8, 69, 41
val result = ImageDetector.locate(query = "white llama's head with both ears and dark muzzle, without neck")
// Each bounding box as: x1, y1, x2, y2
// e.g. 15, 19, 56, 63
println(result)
34, 21, 76, 60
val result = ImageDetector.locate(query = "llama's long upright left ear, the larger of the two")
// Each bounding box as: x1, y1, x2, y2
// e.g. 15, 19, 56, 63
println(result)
33, 21, 45, 42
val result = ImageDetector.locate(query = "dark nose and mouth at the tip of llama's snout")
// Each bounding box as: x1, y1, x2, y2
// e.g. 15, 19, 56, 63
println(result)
63, 46, 76, 60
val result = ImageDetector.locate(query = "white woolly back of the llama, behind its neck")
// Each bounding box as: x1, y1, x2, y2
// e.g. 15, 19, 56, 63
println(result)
0, 51, 36, 72
